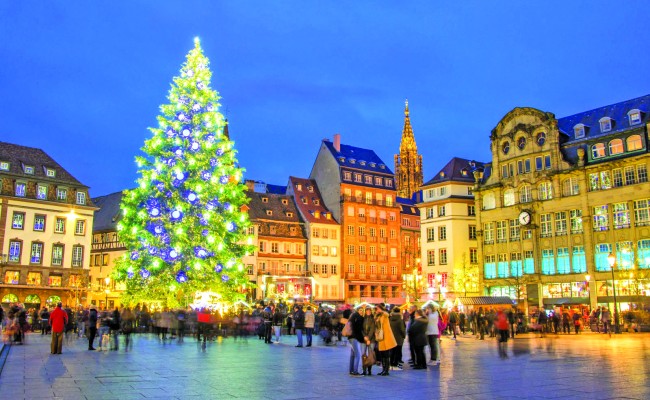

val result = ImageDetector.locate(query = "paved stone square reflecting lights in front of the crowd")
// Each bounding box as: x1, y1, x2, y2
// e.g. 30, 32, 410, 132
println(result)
0, 334, 650, 400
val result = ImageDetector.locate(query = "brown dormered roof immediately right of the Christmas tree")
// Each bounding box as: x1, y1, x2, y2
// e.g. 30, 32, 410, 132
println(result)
246, 190, 301, 223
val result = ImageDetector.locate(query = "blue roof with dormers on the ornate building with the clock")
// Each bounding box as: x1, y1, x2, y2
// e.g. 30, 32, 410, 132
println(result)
557, 95, 650, 143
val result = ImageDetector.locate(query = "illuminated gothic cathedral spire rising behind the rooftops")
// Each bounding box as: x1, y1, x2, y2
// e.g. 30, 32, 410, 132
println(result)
395, 100, 423, 199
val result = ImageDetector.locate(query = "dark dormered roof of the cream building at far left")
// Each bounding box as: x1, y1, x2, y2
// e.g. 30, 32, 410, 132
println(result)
0, 142, 87, 188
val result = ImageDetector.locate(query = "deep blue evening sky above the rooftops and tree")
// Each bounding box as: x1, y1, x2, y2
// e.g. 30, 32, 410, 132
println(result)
0, 0, 650, 196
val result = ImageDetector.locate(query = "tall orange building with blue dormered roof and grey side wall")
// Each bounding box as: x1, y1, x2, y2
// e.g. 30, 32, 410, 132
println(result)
310, 135, 404, 303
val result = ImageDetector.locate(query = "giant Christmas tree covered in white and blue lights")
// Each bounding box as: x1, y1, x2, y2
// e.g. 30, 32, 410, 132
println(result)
113, 39, 253, 306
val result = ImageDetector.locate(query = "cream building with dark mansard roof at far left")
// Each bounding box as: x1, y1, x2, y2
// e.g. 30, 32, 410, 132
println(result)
0, 142, 95, 308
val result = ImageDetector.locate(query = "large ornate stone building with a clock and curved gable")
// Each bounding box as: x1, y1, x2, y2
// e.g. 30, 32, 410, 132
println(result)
475, 96, 650, 310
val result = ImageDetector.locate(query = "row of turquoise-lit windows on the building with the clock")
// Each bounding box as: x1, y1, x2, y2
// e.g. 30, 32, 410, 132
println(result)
484, 239, 650, 279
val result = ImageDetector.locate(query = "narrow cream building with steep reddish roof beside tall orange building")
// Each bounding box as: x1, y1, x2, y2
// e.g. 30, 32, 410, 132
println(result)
287, 177, 344, 303
